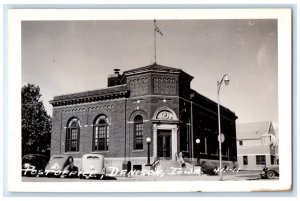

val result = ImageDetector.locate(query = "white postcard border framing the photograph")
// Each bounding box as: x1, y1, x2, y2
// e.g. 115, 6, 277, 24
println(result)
7, 9, 292, 192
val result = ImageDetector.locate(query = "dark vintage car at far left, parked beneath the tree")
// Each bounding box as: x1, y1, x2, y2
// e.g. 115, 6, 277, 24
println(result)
22, 154, 48, 176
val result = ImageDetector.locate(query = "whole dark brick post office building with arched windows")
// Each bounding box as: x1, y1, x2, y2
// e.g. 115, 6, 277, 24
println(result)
50, 63, 237, 170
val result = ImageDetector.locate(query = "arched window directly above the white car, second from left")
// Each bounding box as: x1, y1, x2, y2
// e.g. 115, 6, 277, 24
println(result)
93, 115, 109, 151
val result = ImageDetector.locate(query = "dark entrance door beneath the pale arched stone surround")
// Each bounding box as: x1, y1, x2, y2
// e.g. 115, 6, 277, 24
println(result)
157, 130, 172, 160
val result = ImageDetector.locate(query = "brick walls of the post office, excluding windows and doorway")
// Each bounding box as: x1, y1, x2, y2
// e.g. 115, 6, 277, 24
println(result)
51, 66, 236, 166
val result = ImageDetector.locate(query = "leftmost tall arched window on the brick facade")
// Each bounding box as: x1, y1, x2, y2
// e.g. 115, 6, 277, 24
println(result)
65, 118, 80, 152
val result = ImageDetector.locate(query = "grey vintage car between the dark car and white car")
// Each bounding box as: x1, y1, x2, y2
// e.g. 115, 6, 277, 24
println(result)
45, 154, 78, 177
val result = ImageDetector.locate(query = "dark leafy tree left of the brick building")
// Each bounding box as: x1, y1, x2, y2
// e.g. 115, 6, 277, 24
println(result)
22, 83, 52, 157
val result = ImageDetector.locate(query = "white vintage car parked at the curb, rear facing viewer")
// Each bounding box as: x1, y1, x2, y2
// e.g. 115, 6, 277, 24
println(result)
79, 154, 105, 179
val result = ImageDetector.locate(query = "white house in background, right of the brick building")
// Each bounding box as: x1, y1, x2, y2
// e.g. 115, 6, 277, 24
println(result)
236, 121, 278, 170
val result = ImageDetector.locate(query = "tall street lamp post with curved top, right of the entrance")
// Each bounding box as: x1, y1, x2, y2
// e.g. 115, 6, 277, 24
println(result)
217, 74, 229, 181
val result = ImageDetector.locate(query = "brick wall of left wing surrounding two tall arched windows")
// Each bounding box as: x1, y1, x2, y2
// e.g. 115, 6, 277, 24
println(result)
51, 99, 125, 157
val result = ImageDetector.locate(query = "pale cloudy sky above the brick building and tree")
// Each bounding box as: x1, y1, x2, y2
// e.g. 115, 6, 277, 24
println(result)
21, 19, 278, 123
